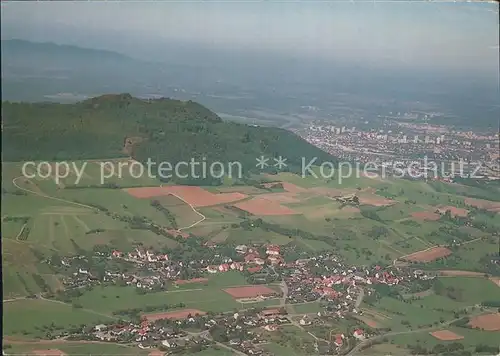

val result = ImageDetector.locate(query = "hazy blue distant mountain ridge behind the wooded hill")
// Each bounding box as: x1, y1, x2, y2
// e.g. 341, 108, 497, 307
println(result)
1, 40, 170, 102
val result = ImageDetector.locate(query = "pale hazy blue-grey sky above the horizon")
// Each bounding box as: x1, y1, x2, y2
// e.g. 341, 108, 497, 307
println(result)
2, 0, 499, 76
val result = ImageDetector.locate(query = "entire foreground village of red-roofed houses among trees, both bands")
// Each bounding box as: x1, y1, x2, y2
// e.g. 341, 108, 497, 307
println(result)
38, 241, 434, 355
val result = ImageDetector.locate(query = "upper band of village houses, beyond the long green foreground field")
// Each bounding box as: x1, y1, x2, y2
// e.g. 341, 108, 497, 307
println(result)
56, 245, 433, 306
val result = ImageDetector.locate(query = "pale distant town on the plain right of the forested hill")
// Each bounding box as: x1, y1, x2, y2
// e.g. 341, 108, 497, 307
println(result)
294, 112, 500, 181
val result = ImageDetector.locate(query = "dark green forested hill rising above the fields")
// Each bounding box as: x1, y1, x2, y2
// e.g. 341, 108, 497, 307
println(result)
2, 94, 334, 184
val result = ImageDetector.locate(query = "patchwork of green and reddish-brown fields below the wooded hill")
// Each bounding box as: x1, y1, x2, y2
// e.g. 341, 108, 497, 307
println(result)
2, 163, 500, 353
